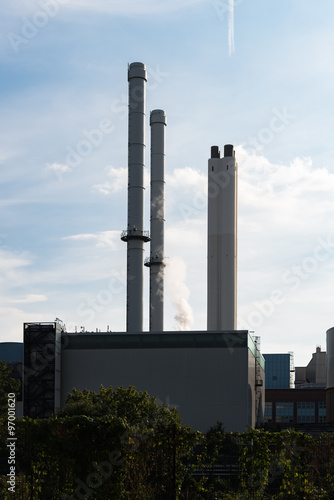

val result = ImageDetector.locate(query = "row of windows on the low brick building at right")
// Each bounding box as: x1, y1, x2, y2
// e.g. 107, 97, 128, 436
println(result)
264, 401, 326, 424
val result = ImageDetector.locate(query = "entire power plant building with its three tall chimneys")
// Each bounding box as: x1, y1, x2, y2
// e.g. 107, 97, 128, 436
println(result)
23, 62, 265, 432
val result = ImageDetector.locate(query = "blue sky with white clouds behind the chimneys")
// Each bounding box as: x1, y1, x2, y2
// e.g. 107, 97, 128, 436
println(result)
0, 0, 334, 365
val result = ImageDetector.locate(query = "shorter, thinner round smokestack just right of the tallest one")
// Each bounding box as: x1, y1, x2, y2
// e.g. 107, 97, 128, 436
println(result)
145, 109, 167, 332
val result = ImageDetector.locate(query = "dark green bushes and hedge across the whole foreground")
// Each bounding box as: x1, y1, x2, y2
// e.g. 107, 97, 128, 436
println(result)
0, 387, 334, 500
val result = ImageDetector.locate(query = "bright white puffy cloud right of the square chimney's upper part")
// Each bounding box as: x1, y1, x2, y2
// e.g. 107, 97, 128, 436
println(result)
237, 147, 334, 238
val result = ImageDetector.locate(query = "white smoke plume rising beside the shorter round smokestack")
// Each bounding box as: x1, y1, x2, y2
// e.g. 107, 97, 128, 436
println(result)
165, 257, 194, 331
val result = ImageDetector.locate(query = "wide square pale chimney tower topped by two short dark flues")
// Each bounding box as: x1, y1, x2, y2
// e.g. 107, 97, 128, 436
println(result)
207, 144, 238, 330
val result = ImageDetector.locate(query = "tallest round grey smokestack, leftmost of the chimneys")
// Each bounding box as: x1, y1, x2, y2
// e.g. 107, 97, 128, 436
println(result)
121, 62, 149, 332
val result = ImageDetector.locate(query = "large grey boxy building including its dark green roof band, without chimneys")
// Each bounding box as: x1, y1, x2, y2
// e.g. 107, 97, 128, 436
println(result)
25, 327, 265, 432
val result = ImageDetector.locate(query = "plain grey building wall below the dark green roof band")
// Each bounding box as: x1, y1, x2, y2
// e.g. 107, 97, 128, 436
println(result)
61, 347, 253, 432
